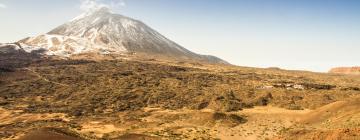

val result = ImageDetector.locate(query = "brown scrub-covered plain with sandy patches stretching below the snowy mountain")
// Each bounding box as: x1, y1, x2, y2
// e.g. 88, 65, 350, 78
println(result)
0, 49, 360, 139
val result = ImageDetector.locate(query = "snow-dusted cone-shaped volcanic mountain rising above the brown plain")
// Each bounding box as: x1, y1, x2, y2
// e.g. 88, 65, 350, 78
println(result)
15, 8, 227, 64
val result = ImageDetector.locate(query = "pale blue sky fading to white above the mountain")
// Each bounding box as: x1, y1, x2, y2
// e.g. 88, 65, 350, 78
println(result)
0, 0, 360, 72
